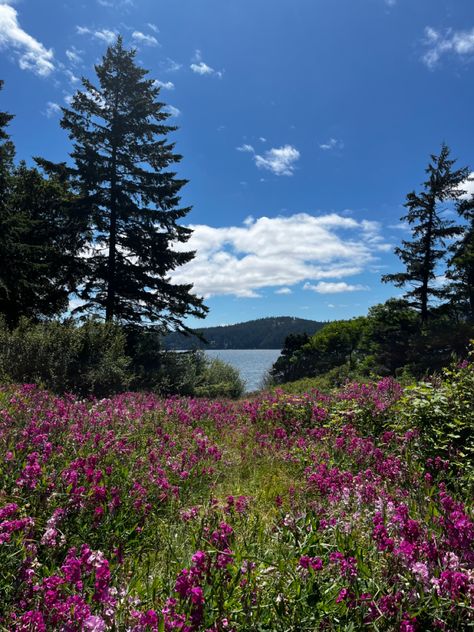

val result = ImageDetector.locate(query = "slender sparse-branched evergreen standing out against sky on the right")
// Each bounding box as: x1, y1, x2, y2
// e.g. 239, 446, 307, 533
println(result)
382, 144, 469, 323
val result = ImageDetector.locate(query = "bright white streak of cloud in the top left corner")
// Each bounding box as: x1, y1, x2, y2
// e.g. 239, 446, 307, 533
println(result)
0, 3, 55, 77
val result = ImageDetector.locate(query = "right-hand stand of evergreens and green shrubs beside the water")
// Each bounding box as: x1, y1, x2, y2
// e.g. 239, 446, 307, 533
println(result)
271, 144, 474, 383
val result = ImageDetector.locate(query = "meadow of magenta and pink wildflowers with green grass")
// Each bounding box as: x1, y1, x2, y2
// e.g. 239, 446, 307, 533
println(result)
0, 379, 474, 632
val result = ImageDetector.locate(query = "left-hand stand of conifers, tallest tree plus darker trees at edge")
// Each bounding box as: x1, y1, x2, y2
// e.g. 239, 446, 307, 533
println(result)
0, 37, 207, 331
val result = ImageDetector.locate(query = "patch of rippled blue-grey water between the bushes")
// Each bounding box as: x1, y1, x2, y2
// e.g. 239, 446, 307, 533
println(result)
205, 349, 280, 393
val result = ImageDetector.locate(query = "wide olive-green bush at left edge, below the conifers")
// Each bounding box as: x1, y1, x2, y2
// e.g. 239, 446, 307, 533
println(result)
0, 319, 131, 397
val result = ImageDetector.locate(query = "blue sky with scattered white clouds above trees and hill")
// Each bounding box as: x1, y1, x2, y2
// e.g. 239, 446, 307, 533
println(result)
0, 0, 474, 325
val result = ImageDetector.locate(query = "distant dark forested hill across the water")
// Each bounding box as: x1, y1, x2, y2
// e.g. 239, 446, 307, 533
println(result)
163, 316, 324, 350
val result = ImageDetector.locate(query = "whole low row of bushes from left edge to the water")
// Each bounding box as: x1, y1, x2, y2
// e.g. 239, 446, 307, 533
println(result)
0, 320, 244, 398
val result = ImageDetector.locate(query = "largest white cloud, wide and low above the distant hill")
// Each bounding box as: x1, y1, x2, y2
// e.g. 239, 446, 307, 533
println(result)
173, 213, 385, 297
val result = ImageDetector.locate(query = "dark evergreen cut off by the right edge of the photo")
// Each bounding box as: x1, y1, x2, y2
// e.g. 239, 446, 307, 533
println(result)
446, 195, 474, 323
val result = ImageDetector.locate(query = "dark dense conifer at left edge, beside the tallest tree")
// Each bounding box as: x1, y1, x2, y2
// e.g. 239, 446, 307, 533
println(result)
0, 83, 84, 327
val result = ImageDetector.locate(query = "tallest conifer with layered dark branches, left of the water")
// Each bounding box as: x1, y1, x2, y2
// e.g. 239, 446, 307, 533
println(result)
55, 37, 207, 331
